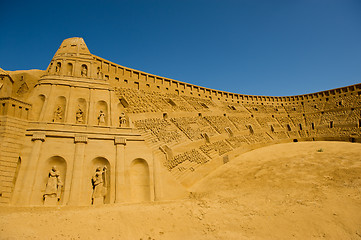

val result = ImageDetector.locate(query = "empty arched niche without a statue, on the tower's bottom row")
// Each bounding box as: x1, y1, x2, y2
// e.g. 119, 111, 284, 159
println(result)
130, 158, 150, 202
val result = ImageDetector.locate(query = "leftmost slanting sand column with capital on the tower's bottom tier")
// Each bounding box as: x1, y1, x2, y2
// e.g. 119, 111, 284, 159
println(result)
20, 132, 45, 205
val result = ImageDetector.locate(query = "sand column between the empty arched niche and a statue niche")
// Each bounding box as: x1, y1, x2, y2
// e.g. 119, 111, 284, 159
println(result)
114, 137, 127, 203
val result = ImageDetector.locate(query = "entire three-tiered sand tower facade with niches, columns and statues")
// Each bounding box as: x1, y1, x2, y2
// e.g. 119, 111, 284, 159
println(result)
12, 38, 163, 205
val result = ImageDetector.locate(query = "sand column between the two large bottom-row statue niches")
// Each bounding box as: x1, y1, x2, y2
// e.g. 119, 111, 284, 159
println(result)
68, 135, 88, 205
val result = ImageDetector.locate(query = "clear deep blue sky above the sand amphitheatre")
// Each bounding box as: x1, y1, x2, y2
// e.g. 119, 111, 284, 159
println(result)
0, 0, 361, 96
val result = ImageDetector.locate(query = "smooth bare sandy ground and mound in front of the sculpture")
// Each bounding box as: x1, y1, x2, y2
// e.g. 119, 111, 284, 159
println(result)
0, 142, 361, 240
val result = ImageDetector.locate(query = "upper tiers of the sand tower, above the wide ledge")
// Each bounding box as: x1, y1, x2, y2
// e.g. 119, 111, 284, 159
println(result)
30, 38, 120, 127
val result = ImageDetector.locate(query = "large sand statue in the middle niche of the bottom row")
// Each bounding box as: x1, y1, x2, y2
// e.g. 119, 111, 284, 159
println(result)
92, 166, 107, 204
